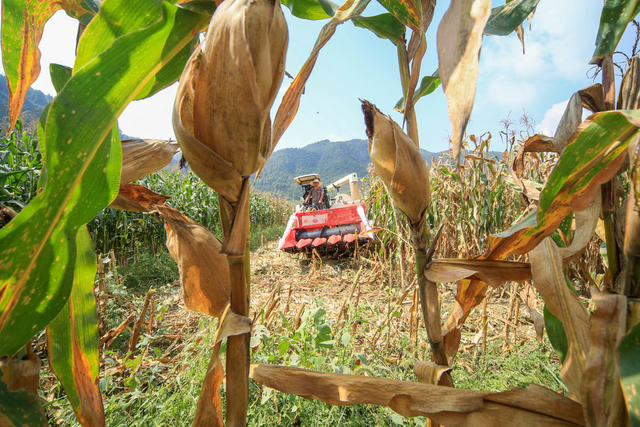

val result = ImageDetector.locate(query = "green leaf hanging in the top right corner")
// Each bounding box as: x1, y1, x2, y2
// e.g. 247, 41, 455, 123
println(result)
591, 0, 640, 63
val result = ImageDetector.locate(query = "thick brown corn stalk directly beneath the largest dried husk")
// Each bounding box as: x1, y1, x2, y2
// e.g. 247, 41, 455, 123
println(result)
220, 197, 250, 427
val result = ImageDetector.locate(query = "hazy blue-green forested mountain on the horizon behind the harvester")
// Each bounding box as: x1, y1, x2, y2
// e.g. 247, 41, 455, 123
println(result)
255, 139, 484, 200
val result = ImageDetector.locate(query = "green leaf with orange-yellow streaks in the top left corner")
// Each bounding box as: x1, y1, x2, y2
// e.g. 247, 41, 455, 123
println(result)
1, 0, 99, 126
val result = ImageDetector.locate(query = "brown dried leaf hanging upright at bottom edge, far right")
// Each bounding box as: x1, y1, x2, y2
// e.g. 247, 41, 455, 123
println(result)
582, 294, 629, 426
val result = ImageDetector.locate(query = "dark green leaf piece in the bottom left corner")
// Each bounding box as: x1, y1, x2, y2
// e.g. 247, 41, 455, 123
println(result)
0, 371, 48, 427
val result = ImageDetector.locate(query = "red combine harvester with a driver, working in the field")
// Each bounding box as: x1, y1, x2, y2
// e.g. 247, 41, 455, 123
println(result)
278, 173, 373, 256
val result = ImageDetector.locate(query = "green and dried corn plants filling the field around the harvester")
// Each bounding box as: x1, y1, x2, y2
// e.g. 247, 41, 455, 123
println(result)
0, 0, 640, 426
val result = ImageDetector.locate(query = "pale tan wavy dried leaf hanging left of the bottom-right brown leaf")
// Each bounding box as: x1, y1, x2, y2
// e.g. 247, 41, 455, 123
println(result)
529, 238, 590, 400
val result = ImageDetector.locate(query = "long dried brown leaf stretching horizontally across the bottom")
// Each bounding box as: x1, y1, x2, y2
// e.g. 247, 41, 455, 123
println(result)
250, 365, 582, 426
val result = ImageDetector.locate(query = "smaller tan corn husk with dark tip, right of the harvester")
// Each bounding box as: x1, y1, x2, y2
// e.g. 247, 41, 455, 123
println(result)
362, 101, 430, 224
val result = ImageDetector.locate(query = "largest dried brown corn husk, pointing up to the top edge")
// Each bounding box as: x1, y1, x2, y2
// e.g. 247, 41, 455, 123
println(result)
173, 0, 288, 203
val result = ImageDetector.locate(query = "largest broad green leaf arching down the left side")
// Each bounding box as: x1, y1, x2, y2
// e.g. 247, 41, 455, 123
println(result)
0, 0, 208, 354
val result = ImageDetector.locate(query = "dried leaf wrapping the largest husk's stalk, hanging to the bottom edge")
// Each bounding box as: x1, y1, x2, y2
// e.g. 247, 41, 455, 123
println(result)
193, 305, 251, 426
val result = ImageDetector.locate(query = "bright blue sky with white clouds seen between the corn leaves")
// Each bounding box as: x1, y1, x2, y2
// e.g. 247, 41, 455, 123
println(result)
10, 0, 634, 151
